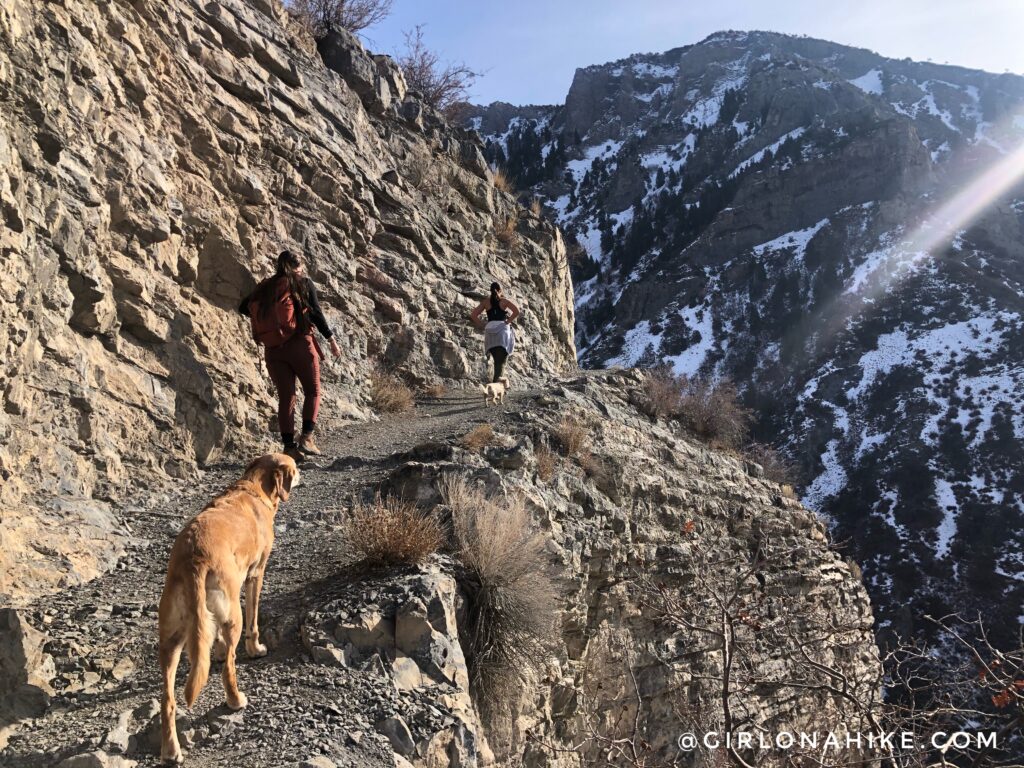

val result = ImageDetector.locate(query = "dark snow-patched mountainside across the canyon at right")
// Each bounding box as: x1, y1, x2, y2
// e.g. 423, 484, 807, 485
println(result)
469, 32, 1024, 634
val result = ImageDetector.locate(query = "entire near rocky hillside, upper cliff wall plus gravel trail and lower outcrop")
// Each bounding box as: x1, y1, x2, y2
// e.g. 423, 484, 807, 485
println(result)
0, 7, 880, 768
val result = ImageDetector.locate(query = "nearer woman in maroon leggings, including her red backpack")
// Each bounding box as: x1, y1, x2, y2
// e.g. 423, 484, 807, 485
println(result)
239, 251, 341, 458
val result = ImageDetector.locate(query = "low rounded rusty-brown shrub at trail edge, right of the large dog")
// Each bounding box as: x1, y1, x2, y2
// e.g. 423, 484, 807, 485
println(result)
345, 495, 442, 565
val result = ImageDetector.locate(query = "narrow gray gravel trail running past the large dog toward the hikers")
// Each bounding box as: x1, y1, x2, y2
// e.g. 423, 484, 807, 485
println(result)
0, 390, 536, 768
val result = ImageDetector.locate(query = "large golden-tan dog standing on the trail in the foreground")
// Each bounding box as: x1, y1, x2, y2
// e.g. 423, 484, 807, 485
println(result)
160, 454, 299, 763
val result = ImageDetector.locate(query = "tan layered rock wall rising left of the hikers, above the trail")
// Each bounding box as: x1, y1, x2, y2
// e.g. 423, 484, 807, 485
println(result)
0, 0, 575, 600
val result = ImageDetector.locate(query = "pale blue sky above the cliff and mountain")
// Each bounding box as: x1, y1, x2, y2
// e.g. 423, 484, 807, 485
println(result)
364, 0, 1024, 103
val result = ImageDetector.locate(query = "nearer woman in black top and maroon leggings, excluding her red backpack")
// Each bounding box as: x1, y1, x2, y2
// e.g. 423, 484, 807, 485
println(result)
239, 251, 341, 459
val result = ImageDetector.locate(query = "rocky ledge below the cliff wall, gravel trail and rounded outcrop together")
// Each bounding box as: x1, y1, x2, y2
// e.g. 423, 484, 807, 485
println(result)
0, 371, 881, 768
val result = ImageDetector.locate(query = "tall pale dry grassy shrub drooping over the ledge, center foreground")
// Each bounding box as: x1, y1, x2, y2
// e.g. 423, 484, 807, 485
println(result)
440, 476, 558, 722
